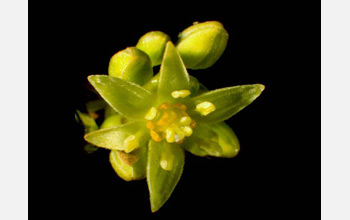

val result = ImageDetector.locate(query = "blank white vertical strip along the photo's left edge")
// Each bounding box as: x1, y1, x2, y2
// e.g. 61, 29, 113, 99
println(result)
0, 0, 28, 220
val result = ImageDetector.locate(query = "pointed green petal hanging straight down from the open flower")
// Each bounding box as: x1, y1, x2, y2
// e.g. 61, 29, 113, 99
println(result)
147, 140, 185, 212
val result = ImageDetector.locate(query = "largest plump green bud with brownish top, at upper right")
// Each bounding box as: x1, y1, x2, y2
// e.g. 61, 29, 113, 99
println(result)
176, 21, 228, 69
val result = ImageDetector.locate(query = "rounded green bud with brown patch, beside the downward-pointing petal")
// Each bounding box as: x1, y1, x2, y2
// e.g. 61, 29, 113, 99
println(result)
109, 146, 147, 181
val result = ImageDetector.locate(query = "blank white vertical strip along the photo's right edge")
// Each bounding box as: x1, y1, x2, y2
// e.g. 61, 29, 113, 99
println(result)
321, 0, 350, 220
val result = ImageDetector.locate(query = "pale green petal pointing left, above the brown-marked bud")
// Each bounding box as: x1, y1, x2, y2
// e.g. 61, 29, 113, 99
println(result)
84, 122, 149, 150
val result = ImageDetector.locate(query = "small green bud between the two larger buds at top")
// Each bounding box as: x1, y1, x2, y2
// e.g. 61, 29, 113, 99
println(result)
136, 31, 170, 66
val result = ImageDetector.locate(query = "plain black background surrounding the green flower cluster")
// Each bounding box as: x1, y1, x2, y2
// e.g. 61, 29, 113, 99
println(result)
29, 1, 321, 219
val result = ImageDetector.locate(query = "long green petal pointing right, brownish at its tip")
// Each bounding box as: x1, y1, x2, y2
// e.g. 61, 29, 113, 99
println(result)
186, 84, 265, 123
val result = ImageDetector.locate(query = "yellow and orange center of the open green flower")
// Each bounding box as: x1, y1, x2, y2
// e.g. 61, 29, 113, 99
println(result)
145, 102, 196, 144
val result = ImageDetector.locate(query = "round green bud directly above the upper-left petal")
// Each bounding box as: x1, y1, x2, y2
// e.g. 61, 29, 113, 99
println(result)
108, 47, 153, 85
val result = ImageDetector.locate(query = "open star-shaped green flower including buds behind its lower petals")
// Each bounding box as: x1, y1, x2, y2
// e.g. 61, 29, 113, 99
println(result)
85, 41, 264, 212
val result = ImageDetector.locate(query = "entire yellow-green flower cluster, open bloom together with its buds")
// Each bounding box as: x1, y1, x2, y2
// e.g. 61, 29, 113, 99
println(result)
80, 22, 264, 212
